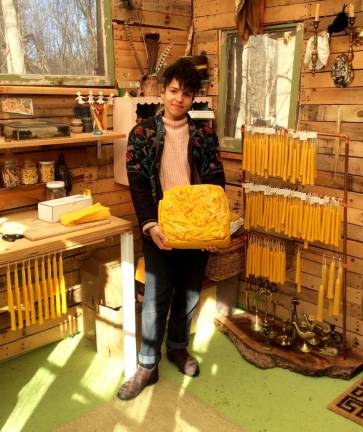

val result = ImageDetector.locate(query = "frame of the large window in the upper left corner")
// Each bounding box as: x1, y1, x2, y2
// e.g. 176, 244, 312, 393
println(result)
0, 0, 116, 87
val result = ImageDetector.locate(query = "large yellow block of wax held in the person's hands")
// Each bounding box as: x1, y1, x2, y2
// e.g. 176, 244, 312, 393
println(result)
159, 184, 231, 249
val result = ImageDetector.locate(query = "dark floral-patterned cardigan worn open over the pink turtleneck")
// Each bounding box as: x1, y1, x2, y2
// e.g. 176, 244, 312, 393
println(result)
126, 113, 225, 228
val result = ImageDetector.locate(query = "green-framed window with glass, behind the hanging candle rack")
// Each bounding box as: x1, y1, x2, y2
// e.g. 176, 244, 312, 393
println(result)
218, 24, 303, 152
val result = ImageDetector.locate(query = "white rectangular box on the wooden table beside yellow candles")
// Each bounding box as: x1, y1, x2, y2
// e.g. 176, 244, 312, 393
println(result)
38, 195, 93, 222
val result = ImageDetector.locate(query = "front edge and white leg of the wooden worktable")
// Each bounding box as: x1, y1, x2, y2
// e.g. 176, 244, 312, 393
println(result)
0, 213, 136, 378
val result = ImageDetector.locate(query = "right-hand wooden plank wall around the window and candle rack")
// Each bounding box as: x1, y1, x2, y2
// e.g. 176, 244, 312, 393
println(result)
194, 0, 363, 349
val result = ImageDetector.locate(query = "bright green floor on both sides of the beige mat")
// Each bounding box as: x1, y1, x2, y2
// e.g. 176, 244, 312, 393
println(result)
0, 320, 363, 432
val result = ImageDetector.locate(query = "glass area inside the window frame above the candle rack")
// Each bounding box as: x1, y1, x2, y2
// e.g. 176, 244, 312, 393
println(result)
224, 30, 296, 138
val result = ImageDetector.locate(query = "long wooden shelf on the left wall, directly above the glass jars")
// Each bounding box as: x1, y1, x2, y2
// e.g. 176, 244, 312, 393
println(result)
0, 131, 126, 150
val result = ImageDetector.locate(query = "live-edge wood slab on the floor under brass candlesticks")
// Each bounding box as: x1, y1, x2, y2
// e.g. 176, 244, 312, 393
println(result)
215, 314, 363, 380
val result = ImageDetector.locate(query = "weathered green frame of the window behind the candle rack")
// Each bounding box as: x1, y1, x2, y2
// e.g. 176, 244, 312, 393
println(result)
217, 22, 304, 153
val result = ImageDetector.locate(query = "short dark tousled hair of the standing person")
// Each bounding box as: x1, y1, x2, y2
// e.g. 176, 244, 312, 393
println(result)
163, 58, 202, 95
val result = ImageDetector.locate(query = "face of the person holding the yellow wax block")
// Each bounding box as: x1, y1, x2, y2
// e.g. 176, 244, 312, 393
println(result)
161, 78, 193, 120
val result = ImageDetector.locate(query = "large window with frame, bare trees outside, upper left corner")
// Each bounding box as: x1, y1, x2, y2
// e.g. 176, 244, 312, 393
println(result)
0, 0, 114, 86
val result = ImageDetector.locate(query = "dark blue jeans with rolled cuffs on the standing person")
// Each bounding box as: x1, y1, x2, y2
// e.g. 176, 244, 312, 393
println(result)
139, 239, 208, 364
